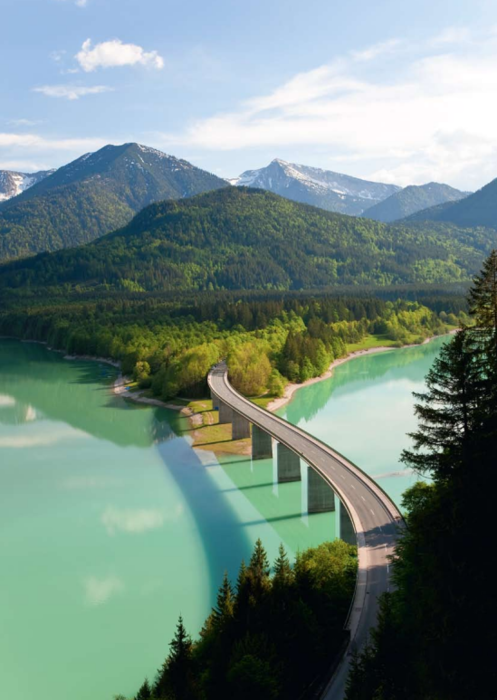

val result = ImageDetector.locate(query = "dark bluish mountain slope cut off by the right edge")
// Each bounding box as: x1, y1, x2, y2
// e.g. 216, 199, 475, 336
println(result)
409, 179, 497, 229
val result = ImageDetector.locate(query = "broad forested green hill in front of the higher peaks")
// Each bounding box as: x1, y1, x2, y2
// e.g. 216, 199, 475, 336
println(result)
0, 187, 497, 297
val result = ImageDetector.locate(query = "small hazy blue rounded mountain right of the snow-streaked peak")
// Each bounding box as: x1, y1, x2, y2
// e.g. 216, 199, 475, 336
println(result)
362, 182, 469, 222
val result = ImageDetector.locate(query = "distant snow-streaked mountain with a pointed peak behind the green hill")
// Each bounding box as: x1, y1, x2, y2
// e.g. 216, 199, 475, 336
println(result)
228, 158, 400, 216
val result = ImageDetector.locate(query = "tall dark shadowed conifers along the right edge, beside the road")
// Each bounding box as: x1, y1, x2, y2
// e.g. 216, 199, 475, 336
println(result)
347, 251, 497, 700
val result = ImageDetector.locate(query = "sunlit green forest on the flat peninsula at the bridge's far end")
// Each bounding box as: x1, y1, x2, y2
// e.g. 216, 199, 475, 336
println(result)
0, 293, 467, 399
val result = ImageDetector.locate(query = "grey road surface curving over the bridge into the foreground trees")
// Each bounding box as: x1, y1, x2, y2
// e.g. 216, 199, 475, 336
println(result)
208, 363, 403, 700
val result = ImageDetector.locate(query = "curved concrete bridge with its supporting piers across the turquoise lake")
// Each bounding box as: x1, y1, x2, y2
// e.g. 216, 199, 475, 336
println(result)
208, 363, 403, 700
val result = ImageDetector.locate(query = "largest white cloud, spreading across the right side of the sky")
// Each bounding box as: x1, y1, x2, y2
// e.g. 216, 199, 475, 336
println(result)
161, 29, 497, 189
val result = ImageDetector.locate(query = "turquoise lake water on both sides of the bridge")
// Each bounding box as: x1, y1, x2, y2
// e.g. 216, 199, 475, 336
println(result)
0, 340, 443, 700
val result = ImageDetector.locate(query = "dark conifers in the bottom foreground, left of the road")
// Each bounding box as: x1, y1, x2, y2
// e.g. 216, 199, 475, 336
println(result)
118, 540, 357, 700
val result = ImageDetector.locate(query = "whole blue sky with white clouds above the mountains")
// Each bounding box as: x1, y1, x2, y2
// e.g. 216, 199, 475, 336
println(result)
0, 0, 497, 191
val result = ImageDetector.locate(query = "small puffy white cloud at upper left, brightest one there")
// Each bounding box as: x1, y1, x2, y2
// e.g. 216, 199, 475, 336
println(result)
75, 39, 164, 73
